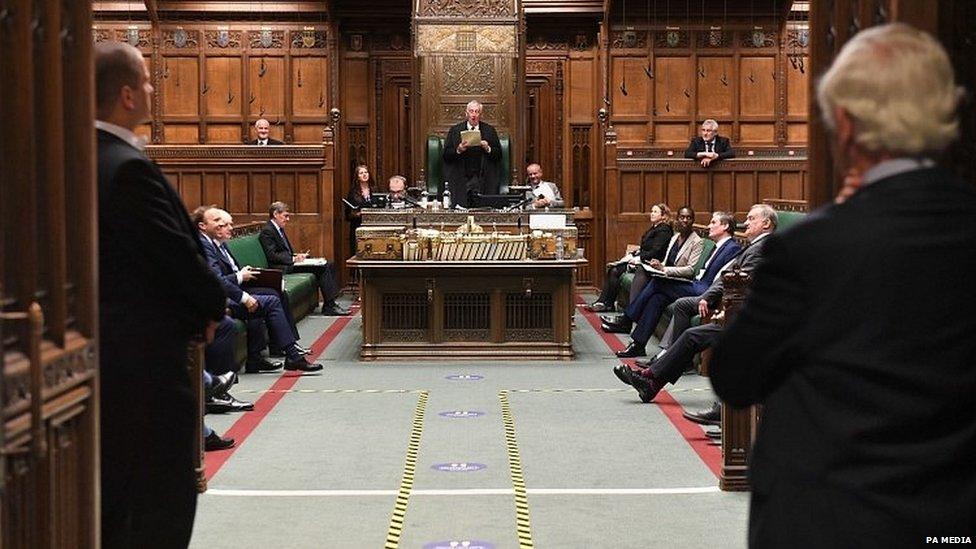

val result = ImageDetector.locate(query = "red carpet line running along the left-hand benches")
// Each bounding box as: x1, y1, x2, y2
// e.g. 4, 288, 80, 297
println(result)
204, 306, 358, 482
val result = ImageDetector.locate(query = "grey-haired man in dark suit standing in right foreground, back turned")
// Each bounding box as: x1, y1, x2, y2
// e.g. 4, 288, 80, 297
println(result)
710, 24, 976, 549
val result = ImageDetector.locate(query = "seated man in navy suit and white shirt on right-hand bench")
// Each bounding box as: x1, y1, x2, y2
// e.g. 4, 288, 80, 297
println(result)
608, 212, 742, 358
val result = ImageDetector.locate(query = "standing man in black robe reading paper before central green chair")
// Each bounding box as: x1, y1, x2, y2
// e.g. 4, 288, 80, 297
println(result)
444, 101, 504, 207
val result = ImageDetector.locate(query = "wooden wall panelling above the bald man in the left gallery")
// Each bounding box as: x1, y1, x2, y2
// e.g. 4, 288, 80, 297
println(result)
92, 21, 336, 144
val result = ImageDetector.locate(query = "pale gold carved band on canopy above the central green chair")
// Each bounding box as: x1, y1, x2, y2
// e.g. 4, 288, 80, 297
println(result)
416, 25, 517, 57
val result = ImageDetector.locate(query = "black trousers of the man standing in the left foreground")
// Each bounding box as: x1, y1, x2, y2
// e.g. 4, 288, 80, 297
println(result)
99, 330, 199, 549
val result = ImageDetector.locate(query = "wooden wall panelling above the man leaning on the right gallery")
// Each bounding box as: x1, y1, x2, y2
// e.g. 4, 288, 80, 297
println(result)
609, 21, 808, 149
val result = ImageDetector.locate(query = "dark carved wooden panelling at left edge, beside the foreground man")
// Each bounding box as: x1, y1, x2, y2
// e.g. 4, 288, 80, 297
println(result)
0, 0, 98, 548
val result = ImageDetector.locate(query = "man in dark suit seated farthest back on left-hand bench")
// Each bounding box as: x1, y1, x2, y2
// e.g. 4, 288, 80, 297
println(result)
258, 202, 349, 316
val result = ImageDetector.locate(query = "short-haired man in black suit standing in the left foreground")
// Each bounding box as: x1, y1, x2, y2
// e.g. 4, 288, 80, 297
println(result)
95, 42, 224, 548
